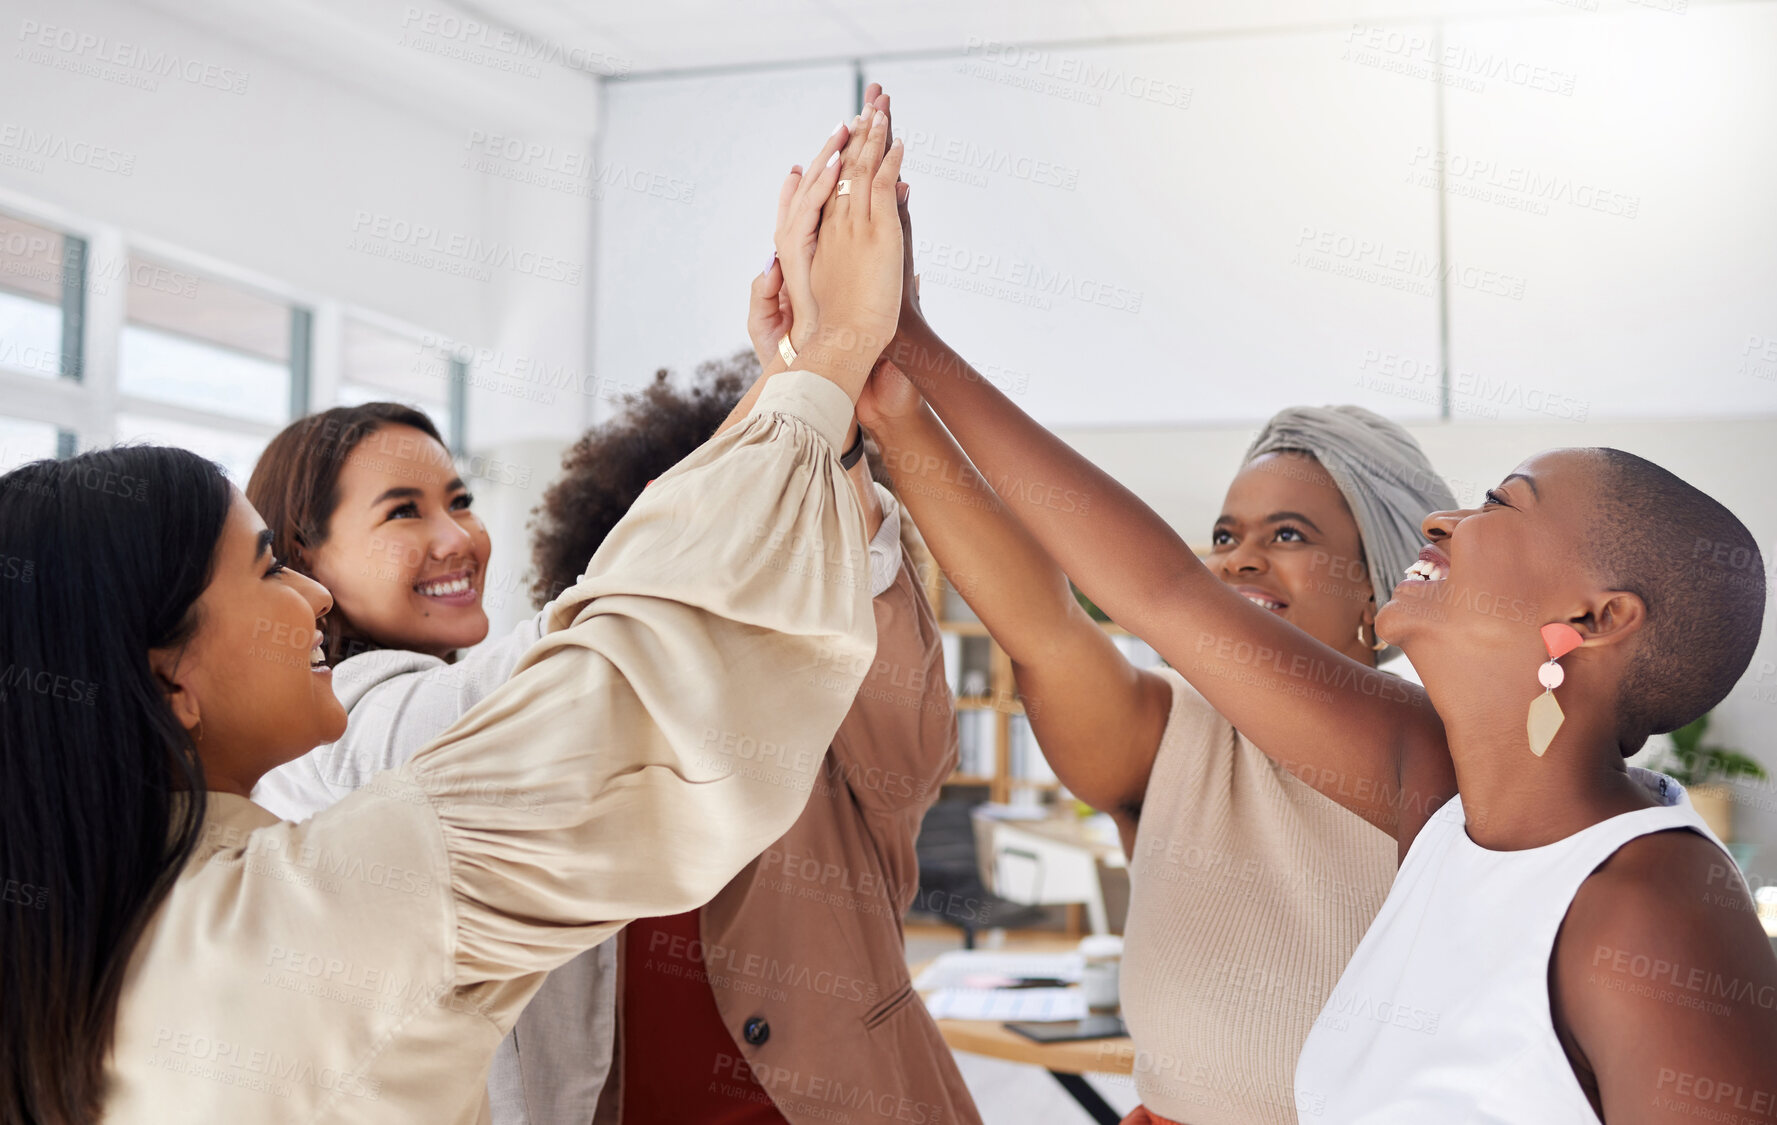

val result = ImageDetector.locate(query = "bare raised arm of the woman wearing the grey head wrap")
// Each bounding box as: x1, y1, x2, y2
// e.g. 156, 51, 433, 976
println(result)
858, 366, 1171, 842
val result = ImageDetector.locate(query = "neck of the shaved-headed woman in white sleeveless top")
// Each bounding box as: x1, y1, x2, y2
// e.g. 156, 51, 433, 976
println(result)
1432, 674, 1651, 851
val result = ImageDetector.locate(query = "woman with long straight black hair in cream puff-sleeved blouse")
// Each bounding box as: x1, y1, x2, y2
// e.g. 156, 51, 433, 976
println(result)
0, 107, 901, 1125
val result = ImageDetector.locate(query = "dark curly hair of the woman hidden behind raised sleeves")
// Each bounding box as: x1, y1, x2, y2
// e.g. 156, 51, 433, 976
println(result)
530, 352, 759, 608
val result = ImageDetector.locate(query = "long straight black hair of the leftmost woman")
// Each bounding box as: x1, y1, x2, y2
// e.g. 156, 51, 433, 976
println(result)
0, 446, 231, 1125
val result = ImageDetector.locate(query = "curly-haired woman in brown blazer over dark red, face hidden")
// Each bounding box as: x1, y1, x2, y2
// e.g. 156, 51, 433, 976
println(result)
517, 334, 979, 1125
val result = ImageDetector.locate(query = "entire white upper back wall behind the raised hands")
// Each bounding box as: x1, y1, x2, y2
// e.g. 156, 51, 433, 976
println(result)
599, 0, 1777, 425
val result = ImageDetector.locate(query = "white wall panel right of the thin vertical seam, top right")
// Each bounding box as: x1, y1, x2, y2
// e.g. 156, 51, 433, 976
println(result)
1445, 2, 1777, 419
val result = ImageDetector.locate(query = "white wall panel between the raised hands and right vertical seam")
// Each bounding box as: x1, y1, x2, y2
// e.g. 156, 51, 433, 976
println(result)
867, 32, 1438, 425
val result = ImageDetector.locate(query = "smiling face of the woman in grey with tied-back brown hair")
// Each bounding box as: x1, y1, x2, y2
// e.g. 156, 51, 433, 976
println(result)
307, 425, 492, 658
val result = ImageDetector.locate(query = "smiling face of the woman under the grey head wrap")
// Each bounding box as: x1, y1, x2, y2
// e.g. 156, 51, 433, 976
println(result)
1203, 453, 1375, 665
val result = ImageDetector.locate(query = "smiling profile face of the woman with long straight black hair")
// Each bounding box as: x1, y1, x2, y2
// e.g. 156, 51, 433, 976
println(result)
161, 491, 345, 796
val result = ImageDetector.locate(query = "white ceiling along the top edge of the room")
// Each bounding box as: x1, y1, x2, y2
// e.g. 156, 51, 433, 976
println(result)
142, 0, 1743, 135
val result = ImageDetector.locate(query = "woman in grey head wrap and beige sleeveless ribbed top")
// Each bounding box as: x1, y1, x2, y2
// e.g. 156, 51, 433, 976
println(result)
858, 364, 1454, 1125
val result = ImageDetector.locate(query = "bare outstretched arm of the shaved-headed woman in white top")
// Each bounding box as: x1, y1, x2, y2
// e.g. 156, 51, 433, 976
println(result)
887, 298, 1455, 846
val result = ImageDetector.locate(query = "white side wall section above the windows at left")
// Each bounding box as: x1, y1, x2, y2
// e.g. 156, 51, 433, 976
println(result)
0, 0, 597, 444
